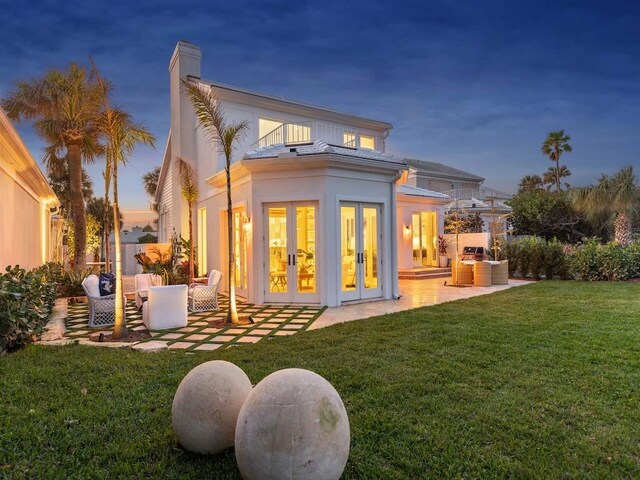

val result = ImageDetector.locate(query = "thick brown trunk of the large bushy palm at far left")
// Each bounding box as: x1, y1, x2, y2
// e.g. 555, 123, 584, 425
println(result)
67, 144, 87, 272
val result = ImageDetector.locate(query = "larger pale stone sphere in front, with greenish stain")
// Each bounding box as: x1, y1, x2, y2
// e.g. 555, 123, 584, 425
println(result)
235, 368, 350, 480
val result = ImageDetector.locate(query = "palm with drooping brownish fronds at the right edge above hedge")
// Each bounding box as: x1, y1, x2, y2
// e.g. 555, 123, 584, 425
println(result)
574, 166, 640, 245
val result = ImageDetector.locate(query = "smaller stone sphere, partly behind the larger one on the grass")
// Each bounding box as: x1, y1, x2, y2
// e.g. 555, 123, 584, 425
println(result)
171, 360, 251, 454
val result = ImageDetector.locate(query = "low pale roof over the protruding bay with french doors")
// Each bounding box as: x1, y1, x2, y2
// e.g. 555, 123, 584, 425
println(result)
244, 140, 404, 165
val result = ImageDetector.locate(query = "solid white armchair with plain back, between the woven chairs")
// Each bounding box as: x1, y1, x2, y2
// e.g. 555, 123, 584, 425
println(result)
142, 285, 188, 330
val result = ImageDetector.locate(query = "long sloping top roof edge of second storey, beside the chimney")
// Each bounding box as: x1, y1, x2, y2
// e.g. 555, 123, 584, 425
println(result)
190, 77, 393, 130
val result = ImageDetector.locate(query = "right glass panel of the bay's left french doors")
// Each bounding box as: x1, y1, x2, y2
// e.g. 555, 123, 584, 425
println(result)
296, 206, 316, 293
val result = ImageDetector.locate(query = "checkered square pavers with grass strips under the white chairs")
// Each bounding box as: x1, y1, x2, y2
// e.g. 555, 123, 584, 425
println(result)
66, 297, 325, 351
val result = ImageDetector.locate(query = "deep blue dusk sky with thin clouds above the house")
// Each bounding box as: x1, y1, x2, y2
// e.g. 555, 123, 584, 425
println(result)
0, 0, 640, 208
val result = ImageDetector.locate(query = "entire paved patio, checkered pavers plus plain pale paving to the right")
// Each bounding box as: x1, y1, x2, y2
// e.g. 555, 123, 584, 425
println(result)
65, 278, 530, 351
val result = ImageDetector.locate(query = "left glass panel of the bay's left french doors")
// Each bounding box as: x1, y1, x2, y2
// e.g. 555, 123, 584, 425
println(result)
267, 207, 289, 293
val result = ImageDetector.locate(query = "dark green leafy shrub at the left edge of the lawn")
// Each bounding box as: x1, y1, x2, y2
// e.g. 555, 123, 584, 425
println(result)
0, 265, 56, 353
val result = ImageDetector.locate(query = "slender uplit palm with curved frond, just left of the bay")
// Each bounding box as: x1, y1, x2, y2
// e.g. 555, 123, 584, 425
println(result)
182, 80, 249, 323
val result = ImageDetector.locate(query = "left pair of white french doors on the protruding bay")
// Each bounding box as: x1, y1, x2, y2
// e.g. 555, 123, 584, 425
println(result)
264, 202, 320, 303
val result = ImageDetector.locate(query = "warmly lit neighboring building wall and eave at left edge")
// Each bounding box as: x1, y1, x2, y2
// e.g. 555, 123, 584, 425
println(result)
0, 109, 59, 271
